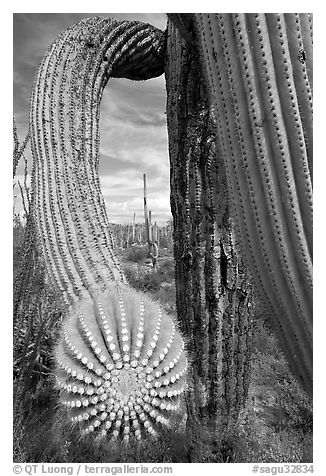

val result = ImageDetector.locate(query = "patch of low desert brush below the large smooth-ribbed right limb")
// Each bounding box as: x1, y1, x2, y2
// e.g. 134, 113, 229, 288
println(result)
233, 317, 313, 463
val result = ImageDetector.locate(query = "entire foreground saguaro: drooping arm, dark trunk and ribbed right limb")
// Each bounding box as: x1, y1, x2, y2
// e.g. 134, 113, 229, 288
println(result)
19, 14, 312, 450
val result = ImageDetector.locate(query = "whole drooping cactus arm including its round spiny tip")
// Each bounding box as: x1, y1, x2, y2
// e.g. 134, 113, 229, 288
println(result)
30, 18, 187, 441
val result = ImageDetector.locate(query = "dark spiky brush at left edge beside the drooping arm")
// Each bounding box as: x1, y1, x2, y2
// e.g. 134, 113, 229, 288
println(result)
13, 215, 61, 462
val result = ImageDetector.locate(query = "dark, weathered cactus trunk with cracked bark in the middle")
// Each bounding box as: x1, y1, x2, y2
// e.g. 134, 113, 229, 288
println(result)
166, 22, 254, 435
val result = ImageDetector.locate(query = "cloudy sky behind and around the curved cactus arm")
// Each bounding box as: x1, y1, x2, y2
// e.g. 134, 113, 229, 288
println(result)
13, 13, 170, 224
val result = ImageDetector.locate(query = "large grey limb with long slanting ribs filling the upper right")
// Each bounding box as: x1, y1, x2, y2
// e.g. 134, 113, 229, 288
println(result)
170, 13, 312, 391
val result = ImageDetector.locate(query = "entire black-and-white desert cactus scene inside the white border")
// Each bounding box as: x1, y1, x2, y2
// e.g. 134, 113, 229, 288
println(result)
11, 3, 314, 468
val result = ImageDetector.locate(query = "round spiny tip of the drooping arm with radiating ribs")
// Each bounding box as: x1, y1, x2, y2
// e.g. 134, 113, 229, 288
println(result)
56, 284, 187, 442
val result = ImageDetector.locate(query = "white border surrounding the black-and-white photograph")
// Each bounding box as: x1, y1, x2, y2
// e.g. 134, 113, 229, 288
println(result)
0, 0, 326, 475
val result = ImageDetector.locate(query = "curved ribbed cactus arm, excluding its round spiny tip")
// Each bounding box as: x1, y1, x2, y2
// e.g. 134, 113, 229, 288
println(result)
30, 18, 164, 303
